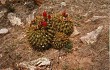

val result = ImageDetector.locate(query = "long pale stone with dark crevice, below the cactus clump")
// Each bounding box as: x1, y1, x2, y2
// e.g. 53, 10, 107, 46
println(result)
17, 57, 50, 70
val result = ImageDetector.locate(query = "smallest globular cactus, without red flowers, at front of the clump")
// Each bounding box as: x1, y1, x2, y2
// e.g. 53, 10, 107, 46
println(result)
52, 32, 69, 50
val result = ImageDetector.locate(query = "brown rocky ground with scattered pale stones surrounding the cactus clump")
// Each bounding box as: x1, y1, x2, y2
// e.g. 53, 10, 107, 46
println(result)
0, 0, 110, 70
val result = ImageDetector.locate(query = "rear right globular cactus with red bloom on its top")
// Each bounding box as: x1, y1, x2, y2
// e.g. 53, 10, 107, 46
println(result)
54, 11, 73, 36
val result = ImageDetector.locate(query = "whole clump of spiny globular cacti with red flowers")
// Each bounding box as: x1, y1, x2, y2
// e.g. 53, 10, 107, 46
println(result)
27, 11, 73, 51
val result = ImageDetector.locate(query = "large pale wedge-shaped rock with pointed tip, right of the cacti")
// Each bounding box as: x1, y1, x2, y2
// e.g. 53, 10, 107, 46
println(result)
80, 26, 103, 44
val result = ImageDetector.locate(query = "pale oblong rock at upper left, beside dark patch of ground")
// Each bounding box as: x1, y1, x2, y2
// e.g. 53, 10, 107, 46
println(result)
8, 13, 23, 26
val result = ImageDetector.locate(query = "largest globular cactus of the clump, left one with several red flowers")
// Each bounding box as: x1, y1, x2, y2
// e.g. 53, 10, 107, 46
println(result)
27, 11, 54, 51
